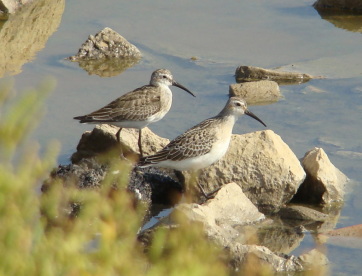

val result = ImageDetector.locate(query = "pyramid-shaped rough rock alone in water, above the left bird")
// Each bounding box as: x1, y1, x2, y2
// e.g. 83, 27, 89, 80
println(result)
68, 28, 142, 61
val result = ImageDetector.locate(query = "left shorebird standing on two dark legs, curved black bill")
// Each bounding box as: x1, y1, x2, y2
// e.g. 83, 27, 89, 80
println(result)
74, 69, 195, 156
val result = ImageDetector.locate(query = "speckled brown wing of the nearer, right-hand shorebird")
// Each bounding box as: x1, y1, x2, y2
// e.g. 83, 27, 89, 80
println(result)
141, 118, 218, 164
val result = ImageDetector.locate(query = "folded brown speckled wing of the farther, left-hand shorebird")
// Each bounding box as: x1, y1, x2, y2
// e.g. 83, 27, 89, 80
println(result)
75, 85, 161, 123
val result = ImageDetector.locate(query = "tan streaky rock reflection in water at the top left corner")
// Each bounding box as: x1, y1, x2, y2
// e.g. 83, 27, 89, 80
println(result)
0, 0, 65, 77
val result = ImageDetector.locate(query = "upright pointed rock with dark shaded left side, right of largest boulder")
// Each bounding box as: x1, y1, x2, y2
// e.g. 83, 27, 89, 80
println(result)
295, 148, 348, 204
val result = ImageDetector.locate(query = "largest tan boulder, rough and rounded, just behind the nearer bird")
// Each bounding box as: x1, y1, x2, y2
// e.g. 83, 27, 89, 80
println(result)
191, 130, 305, 212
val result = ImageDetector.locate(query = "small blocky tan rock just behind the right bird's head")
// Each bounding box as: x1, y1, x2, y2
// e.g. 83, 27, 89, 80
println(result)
229, 80, 282, 105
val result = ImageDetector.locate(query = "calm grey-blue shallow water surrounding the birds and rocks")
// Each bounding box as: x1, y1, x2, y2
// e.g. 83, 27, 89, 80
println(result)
0, 0, 362, 275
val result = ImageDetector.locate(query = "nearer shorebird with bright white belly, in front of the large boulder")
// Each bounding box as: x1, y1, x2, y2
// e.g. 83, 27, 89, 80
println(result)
138, 97, 266, 171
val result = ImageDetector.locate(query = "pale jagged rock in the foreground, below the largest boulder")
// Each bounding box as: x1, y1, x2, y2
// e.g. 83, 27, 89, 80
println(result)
146, 183, 326, 273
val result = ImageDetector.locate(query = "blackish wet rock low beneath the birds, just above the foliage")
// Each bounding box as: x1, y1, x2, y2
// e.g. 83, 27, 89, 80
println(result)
41, 155, 184, 205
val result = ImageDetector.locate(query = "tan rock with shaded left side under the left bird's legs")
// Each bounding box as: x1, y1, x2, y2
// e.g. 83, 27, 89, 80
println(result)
71, 124, 169, 163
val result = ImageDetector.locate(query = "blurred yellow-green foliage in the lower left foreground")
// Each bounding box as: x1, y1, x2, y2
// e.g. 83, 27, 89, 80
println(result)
0, 80, 229, 276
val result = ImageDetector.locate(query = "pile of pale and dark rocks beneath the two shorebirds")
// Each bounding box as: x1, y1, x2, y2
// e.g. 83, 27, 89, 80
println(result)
51, 122, 347, 271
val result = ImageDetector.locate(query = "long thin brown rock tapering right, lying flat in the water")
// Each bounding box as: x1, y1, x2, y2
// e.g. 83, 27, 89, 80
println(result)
235, 66, 319, 84
